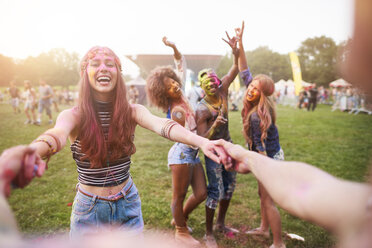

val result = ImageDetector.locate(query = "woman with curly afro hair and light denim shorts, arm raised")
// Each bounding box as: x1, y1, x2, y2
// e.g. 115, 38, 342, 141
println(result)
146, 37, 207, 246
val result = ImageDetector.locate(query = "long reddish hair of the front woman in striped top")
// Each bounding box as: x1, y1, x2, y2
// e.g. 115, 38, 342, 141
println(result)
78, 47, 136, 168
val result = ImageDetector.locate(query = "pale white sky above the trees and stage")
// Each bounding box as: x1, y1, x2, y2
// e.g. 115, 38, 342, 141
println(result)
0, 0, 353, 75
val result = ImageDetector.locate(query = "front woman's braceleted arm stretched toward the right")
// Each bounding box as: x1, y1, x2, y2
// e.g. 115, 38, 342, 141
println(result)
132, 104, 220, 163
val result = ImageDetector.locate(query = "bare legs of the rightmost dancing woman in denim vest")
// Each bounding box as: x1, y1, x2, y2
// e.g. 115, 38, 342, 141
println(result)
247, 182, 285, 248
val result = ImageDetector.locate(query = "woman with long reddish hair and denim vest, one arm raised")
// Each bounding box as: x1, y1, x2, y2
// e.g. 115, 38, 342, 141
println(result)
235, 23, 285, 248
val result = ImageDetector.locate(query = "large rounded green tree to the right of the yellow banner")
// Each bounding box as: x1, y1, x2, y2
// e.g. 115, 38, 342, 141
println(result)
297, 36, 338, 86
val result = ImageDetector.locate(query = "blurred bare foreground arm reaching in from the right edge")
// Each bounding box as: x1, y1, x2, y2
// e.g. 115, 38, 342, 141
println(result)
219, 140, 372, 234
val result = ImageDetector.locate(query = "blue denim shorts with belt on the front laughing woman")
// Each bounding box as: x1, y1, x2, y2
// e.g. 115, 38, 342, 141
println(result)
70, 177, 144, 238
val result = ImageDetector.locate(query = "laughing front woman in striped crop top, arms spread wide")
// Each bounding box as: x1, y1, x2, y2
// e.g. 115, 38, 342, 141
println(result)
4, 47, 224, 237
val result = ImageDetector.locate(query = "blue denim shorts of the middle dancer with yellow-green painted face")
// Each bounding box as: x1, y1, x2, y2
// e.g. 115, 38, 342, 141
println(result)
205, 156, 236, 209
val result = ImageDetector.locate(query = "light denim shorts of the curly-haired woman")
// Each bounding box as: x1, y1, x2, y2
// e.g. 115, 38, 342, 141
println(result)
168, 142, 200, 167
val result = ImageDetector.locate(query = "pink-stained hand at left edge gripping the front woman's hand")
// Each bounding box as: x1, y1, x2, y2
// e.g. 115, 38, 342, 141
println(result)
0, 146, 46, 197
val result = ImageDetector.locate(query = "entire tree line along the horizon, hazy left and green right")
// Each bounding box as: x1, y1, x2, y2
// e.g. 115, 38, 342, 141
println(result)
0, 36, 349, 86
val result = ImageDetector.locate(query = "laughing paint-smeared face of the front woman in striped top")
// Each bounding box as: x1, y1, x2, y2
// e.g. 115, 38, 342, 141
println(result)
87, 49, 118, 100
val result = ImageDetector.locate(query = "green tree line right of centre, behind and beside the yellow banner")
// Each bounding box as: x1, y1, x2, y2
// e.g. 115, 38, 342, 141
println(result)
217, 36, 349, 87
